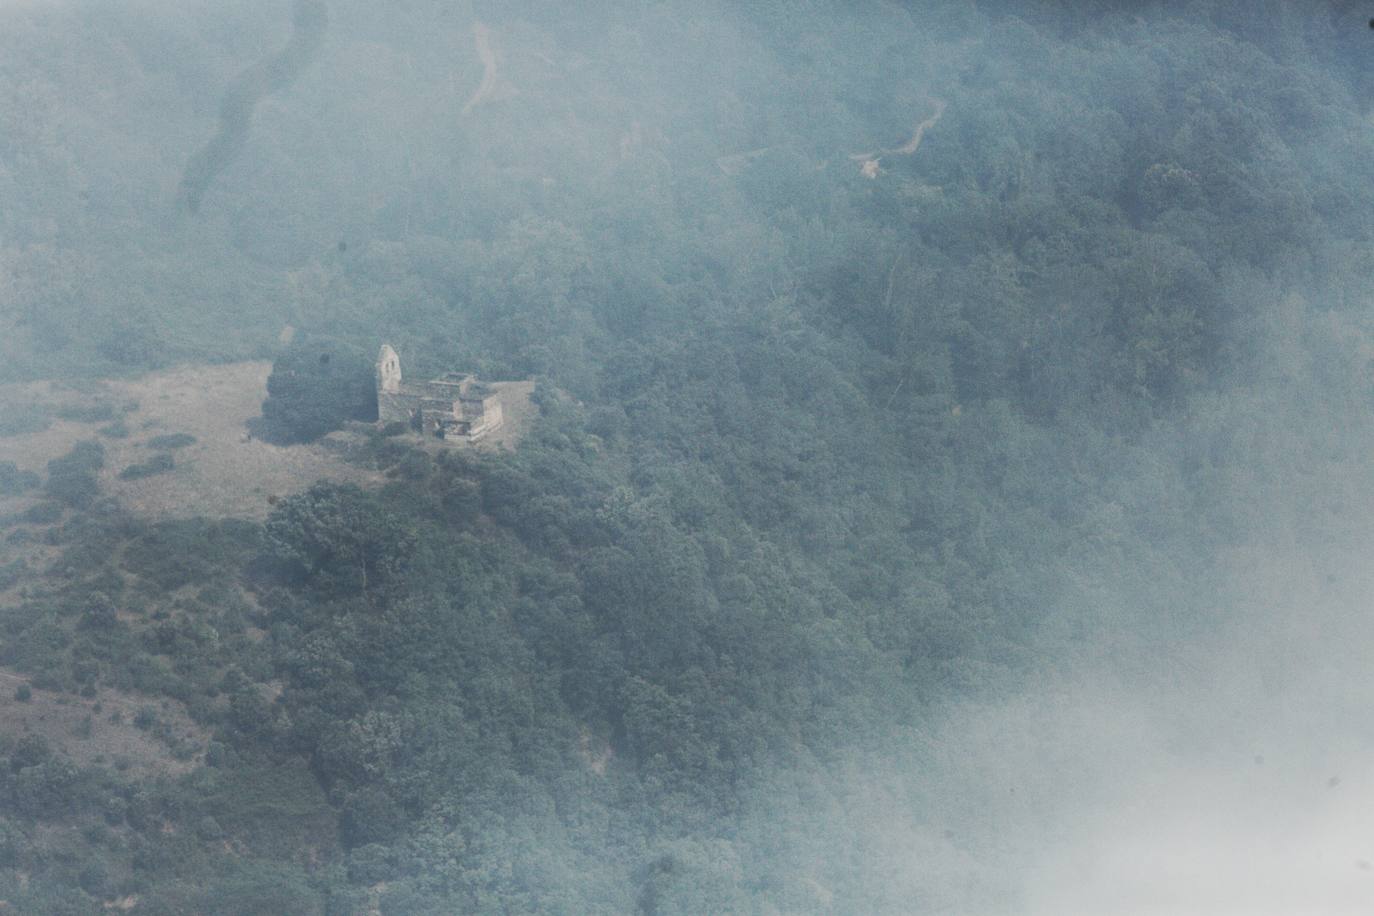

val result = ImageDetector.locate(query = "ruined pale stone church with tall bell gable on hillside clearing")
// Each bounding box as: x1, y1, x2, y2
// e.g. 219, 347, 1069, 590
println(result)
376, 343, 503, 442
